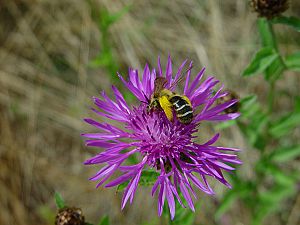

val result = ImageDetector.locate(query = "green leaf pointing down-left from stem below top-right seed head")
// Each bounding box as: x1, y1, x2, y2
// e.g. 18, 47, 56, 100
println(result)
242, 47, 279, 76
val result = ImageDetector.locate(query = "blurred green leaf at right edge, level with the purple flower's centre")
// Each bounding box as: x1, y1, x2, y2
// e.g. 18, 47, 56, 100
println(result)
270, 111, 300, 138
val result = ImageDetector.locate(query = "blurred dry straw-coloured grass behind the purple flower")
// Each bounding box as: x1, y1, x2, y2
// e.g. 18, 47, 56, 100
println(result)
0, 0, 300, 225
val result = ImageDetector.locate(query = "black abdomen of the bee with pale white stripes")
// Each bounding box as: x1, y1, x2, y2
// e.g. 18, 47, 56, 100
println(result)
169, 95, 193, 124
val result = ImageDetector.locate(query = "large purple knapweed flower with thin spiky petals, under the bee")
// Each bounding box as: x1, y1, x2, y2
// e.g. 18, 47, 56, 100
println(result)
83, 57, 240, 218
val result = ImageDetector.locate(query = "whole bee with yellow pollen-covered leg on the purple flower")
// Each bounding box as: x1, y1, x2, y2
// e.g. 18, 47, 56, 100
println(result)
148, 77, 193, 124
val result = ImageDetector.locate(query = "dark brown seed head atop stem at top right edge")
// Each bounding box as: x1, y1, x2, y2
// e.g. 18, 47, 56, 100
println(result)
250, 0, 289, 19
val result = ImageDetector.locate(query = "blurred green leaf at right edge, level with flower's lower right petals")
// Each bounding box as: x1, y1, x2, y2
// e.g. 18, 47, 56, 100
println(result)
271, 145, 300, 162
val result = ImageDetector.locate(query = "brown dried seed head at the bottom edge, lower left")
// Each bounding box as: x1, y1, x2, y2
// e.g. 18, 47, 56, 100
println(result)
55, 208, 84, 225
